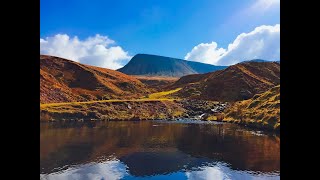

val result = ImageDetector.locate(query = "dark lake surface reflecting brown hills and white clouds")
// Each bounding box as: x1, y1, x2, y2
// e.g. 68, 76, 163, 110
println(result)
40, 120, 280, 180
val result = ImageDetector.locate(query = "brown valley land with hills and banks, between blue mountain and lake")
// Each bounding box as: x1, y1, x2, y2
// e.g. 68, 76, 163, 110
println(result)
40, 55, 280, 131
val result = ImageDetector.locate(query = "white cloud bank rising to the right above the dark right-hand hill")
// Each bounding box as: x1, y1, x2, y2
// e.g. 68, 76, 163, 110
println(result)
185, 24, 280, 65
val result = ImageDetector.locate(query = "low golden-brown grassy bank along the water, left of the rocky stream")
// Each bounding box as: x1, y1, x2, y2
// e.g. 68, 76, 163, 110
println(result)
40, 100, 184, 121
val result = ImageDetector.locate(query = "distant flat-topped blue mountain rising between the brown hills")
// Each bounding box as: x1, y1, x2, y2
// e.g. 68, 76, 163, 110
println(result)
118, 54, 227, 77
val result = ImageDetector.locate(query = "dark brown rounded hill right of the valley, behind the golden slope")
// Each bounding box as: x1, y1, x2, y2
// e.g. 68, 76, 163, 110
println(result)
170, 62, 280, 101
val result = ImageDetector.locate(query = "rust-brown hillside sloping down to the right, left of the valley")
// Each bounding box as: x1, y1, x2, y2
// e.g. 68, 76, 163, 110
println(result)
40, 55, 149, 103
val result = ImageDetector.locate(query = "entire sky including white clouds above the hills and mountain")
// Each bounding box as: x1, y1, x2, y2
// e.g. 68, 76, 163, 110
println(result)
40, 0, 280, 69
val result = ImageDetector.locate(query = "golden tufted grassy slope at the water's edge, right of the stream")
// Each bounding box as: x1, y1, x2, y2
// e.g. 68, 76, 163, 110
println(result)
225, 85, 280, 130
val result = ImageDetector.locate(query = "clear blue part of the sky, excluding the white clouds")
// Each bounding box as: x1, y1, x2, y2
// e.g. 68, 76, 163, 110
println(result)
40, 0, 280, 67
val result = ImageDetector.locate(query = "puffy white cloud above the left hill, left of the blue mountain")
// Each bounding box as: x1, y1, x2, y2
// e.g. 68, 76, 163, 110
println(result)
40, 34, 131, 69
